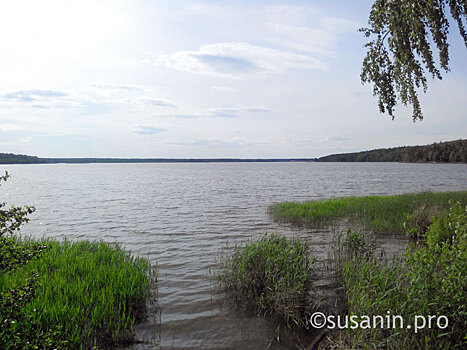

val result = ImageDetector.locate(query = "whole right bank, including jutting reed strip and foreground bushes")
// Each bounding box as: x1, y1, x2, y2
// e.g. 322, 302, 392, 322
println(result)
269, 191, 467, 349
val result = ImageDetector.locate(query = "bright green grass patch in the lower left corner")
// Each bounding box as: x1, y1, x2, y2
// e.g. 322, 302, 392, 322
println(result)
0, 241, 156, 349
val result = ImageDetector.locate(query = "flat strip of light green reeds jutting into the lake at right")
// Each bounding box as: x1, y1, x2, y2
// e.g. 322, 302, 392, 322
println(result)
269, 191, 467, 234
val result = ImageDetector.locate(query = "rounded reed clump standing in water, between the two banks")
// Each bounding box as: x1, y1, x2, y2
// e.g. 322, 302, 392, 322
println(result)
219, 234, 314, 328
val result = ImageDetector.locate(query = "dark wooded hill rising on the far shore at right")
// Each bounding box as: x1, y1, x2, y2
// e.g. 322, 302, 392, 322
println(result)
317, 140, 467, 163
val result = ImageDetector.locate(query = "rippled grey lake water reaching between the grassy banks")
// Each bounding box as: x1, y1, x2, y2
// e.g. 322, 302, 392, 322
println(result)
0, 163, 467, 349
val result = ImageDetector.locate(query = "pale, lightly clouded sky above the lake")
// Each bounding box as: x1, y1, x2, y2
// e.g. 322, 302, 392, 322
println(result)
0, 0, 467, 158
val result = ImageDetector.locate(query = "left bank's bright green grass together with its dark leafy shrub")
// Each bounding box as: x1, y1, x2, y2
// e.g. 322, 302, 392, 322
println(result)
0, 172, 157, 350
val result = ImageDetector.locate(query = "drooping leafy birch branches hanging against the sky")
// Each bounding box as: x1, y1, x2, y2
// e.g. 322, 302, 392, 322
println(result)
360, 0, 467, 121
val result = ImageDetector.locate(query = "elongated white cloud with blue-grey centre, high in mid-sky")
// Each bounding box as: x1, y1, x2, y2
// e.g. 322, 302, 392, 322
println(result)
161, 42, 326, 79
